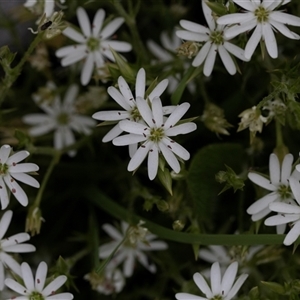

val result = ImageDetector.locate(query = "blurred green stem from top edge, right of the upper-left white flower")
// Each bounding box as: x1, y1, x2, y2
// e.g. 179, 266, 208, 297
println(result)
113, 0, 149, 63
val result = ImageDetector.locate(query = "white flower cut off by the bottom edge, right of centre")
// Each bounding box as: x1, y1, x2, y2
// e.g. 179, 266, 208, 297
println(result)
175, 262, 248, 300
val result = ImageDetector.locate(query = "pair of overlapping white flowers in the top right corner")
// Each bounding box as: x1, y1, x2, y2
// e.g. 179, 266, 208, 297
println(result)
176, 0, 300, 76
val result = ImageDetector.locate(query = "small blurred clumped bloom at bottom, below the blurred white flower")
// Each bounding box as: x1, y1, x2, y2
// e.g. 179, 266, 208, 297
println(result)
84, 268, 125, 295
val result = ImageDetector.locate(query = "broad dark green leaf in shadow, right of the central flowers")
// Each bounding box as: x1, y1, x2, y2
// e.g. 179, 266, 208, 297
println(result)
187, 144, 244, 221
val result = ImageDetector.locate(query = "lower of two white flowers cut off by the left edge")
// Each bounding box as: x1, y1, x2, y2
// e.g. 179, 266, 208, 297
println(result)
0, 210, 35, 291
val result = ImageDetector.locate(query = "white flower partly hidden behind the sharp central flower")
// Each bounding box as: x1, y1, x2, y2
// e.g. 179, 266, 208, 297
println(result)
92, 68, 175, 157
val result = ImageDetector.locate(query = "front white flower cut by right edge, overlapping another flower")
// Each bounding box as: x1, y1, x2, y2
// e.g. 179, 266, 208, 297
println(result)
265, 172, 300, 246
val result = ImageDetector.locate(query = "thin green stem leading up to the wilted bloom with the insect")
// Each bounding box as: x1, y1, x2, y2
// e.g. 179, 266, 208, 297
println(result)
0, 32, 44, 105
